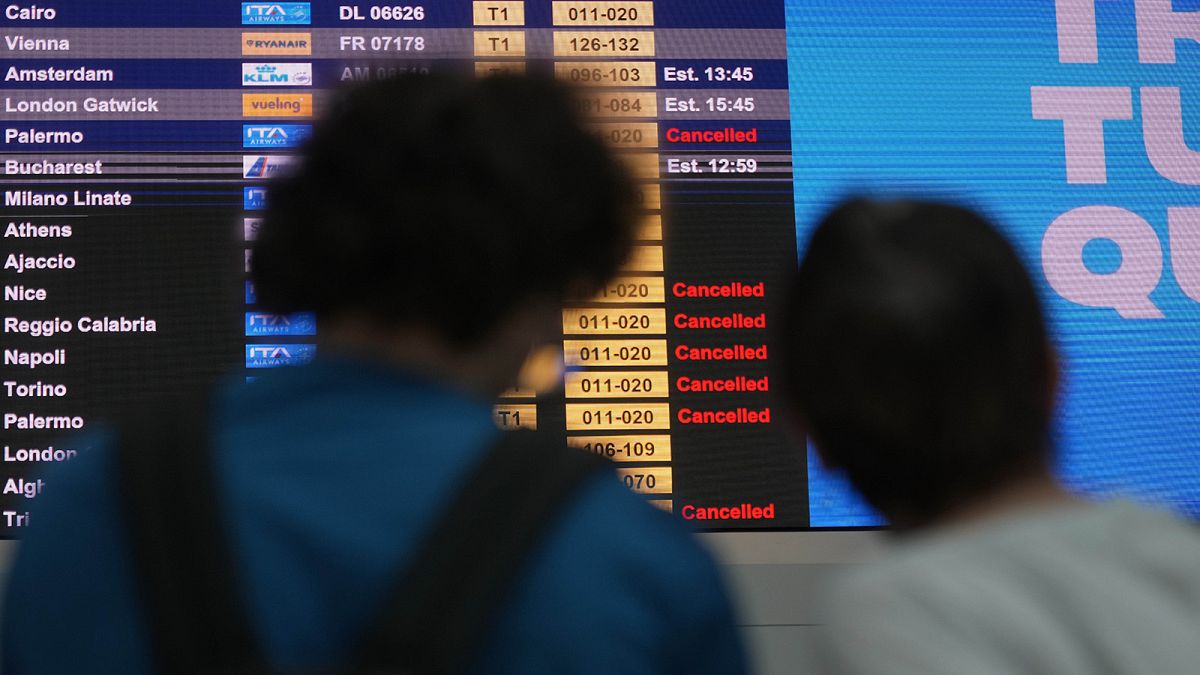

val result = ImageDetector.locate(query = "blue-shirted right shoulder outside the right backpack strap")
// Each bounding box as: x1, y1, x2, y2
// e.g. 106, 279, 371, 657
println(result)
488, 471, 745, 675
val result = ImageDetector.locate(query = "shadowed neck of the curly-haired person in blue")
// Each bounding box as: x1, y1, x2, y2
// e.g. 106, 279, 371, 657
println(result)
319, 319, 521, 396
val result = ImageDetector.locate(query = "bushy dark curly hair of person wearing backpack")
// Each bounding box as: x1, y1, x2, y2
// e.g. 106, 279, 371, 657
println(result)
251, 72, 634, 346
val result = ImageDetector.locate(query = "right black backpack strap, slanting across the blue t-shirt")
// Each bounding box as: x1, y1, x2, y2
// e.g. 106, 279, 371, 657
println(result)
359, 431, 612, 675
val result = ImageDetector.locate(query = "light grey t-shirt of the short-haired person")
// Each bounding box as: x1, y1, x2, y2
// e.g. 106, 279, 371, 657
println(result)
806, 502, 1200, 675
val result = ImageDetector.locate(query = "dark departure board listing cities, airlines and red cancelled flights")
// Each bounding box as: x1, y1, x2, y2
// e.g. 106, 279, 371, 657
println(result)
0, 0, 808, 534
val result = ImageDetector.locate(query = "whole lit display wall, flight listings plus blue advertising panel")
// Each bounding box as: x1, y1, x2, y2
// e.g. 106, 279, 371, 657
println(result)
0, 0, 1200, 537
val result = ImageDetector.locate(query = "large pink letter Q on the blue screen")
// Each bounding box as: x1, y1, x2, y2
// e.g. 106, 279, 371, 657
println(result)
1042, 207, 1163, 318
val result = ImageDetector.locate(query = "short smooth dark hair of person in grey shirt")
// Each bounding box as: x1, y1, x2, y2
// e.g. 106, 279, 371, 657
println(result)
784, 199, 1055, 525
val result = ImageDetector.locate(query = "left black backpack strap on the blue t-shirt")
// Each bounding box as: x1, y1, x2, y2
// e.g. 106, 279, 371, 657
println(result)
116, 398, 268, 675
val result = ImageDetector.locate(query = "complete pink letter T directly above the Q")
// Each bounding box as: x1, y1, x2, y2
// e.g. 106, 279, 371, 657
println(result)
1030, 86, 1133, 183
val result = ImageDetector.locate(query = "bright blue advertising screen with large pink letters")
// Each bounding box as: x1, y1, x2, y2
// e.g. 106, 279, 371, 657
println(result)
787, 0, 1200, 526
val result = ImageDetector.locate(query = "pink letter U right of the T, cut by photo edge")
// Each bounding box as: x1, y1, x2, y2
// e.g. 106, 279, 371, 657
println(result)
1141, 86, 1200, 185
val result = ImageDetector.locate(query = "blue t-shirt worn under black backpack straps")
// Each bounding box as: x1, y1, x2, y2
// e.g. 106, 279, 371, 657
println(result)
2, 359, 745, 675
